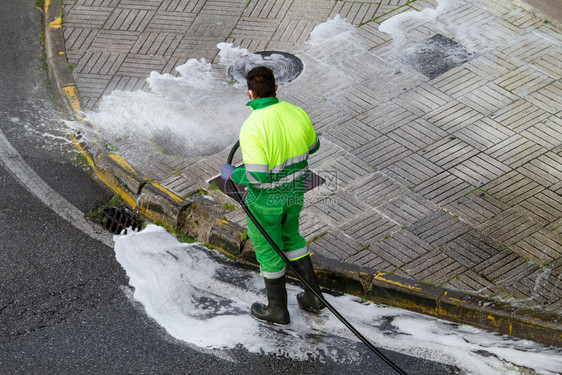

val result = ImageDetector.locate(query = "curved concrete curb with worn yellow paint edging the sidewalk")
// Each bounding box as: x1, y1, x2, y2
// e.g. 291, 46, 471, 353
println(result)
45, 0, 562, 346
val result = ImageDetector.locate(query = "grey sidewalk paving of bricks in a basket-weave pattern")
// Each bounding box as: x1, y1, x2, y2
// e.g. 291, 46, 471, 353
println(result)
64, 0, 562, 312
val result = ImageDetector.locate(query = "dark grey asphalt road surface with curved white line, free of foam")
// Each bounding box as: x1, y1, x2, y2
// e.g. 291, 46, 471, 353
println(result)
0, 0, 455, 374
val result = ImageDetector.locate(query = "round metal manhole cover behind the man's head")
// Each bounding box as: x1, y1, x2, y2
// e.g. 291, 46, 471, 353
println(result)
228, 51, 304, 85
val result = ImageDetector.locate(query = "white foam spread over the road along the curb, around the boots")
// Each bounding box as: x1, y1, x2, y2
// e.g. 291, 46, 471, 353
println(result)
115, 225, 562, 374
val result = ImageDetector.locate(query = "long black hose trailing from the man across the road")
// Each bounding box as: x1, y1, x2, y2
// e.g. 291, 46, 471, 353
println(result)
227, 141, 407, 375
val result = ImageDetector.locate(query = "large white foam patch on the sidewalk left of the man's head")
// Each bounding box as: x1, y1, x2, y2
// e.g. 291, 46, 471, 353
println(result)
84, 59, 250, 158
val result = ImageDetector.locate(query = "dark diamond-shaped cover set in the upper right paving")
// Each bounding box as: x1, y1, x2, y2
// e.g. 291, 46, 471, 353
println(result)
394, 34, 474, 79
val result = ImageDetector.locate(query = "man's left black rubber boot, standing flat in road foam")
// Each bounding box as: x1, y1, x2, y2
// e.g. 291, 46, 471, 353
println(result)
252, 276, 291, 325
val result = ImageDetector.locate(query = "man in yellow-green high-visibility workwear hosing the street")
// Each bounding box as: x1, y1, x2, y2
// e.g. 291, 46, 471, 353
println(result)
221, 67, 325, 324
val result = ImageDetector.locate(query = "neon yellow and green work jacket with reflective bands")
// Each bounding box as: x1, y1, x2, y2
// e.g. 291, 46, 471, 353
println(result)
231, 97, 320, 200
